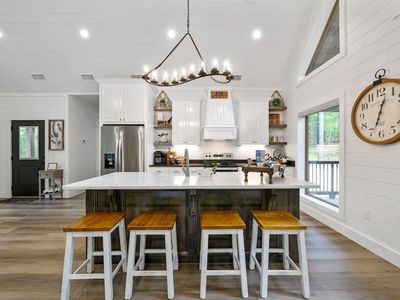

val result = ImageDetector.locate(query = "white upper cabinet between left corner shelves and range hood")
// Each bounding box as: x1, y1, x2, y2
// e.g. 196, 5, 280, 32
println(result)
172, 101, 200, 145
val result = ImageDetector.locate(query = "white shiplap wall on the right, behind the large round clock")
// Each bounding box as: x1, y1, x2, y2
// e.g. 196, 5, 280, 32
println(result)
284, 0, 400, 266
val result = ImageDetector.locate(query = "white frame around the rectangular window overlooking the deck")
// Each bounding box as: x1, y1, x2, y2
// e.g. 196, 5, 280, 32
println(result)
296, 93, 346, 220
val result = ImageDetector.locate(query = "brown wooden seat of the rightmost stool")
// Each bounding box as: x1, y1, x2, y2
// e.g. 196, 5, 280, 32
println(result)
251, 210, 307, 230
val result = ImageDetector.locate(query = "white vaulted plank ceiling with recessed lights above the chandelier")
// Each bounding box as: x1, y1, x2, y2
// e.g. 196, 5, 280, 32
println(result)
0, 0, 313, 93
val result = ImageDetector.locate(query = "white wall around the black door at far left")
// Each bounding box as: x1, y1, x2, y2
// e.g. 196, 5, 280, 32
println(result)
0, 94, 68, 198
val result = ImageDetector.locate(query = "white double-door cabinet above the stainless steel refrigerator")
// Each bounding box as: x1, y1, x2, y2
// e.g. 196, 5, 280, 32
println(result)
100, 83, 146, 124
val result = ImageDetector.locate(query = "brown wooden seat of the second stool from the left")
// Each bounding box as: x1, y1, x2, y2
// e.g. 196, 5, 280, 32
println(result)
128, 210, 176, 230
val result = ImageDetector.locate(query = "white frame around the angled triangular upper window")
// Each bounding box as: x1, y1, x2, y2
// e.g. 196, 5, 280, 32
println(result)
297, 0, 347, 86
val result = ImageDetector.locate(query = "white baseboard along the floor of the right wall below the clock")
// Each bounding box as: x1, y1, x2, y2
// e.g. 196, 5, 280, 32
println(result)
301, 201, 400, 268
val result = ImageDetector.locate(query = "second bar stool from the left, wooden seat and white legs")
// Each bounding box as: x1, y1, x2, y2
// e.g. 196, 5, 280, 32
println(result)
125, 211, 178, 299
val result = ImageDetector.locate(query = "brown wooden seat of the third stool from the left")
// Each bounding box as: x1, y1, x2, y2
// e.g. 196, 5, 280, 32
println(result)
200, 210, 246, 229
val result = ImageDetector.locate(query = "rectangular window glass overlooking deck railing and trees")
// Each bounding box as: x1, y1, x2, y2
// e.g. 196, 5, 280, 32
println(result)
305, 106, 340, 207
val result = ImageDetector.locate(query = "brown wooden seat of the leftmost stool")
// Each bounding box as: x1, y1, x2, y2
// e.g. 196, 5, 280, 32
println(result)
64, 212, 125, 232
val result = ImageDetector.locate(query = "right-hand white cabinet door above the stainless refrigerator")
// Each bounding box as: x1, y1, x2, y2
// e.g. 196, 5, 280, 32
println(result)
122, 85, 145, 124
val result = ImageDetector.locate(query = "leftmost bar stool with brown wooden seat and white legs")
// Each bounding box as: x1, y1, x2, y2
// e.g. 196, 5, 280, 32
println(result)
61, 213, 126, 300
